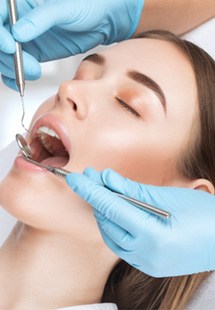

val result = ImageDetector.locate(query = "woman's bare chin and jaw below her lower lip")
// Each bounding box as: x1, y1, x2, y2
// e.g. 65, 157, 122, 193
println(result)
0, 169, 99, 241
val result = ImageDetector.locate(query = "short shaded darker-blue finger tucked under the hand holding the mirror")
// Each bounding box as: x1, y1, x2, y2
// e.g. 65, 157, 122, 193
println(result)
94, 210, 133, 251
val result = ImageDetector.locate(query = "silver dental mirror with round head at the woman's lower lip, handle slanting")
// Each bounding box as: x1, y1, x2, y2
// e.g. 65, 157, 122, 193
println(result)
16, 134, 171, 218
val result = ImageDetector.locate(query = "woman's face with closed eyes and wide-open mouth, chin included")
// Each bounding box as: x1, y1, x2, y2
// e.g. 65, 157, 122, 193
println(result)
0, 39, 198, 239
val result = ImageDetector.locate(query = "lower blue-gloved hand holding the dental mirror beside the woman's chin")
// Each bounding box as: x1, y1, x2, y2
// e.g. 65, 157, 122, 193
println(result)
67, 168, 215, 277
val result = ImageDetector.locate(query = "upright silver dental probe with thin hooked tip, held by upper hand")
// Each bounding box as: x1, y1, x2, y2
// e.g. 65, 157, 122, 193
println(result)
8, 0, 28, 131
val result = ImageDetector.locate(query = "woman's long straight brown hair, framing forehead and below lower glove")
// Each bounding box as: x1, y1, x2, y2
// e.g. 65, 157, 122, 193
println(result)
102, 30, 215, 310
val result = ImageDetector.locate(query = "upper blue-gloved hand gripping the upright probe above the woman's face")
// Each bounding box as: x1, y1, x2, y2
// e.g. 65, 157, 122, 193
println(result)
0, 0, 144, 89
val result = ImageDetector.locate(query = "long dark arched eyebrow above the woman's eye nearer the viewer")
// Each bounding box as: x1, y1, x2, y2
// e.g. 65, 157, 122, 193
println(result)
127, 70, 166, 113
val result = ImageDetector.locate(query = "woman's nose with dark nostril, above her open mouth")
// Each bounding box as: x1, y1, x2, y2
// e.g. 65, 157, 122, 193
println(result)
56, 81, 88, 120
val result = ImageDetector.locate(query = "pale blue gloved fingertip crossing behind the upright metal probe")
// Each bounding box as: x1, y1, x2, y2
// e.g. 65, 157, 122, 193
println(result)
0, 51, 41, 81
